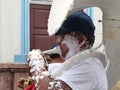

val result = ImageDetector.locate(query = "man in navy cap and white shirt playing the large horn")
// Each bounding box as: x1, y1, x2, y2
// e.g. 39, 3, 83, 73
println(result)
17, 11, 107, 90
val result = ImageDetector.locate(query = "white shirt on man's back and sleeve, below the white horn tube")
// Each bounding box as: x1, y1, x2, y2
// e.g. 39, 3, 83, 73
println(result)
48, 57, 108, 90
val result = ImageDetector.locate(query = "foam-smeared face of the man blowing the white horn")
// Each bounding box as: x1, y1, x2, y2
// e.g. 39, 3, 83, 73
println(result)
57, 34, 79, 59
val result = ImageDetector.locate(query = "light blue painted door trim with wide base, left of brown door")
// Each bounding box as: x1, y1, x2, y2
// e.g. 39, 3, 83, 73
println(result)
14, 0, 29, 63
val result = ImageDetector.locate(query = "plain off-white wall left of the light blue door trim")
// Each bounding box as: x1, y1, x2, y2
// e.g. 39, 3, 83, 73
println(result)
0, 0, 21, 63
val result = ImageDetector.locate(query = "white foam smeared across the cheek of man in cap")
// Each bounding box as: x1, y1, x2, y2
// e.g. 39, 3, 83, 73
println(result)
62, 35, 80, 60
